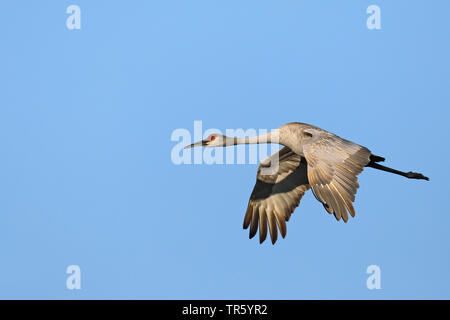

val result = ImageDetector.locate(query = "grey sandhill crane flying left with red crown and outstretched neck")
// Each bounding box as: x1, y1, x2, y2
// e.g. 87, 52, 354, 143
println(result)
185, 122, 429, 244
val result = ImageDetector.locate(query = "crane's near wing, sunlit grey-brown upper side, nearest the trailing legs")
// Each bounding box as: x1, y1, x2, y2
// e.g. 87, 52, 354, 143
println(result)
303, 128, 371, 222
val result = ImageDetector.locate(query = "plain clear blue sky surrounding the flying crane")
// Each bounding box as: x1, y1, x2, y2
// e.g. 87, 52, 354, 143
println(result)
0, 0, 450, 299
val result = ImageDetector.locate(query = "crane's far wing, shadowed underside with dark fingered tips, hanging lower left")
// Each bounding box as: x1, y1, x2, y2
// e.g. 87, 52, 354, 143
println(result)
244, 147, 309, 244
